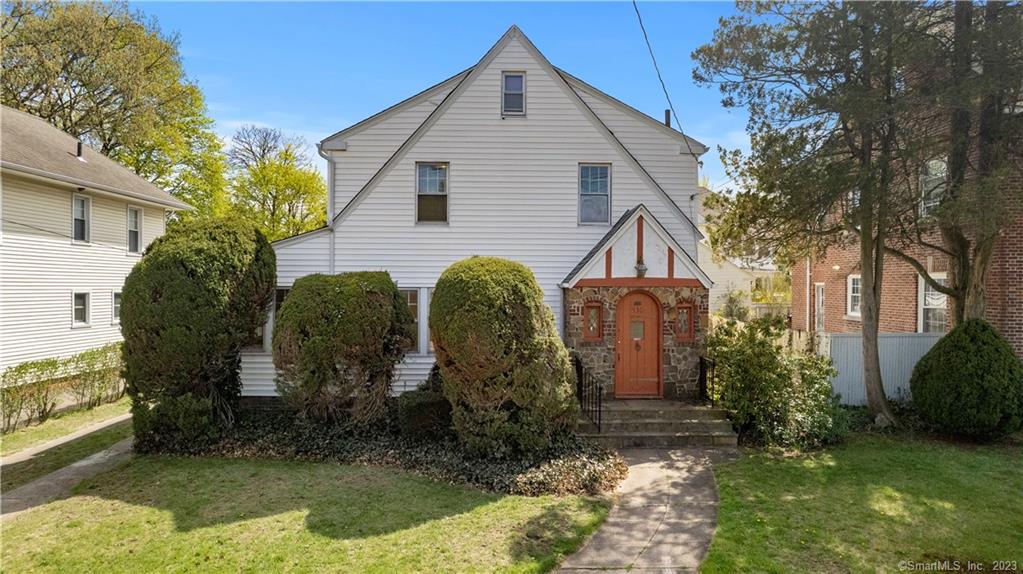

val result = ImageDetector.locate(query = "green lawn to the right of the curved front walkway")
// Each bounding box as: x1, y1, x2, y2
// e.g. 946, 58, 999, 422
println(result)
701, 435, 1023, 572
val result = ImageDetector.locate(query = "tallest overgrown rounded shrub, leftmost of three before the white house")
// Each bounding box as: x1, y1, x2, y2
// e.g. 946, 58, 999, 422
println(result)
121, 219, 276, 451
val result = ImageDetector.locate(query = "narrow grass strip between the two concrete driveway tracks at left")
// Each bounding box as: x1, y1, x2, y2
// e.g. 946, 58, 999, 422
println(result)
0, 421, 132, 492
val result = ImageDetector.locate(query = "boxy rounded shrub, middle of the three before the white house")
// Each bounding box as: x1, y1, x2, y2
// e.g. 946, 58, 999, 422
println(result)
273, 271, 414, 424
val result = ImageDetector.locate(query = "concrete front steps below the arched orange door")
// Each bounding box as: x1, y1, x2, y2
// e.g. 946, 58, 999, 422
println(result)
579, 399, 738, 448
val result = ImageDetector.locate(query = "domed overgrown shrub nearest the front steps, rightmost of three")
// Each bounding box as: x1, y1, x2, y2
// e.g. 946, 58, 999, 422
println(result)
430, 257, 577, 457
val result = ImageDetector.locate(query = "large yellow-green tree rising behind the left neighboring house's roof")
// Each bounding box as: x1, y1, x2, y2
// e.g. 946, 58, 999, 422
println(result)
0, 1, 226, 215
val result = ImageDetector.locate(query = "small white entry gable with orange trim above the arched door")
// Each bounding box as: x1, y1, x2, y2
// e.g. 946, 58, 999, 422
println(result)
561, 204, 714, 289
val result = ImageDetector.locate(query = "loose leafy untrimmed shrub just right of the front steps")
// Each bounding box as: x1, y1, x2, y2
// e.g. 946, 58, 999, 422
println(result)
708, 319, 849, 448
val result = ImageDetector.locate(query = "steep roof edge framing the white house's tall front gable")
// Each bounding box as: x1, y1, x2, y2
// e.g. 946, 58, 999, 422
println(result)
330, 26, 703, 237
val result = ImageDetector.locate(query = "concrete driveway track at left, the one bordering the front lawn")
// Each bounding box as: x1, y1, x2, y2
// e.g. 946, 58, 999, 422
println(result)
0, 438, 135, 521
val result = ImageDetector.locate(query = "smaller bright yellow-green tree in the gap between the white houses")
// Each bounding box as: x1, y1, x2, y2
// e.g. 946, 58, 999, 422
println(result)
228, 126, 327, 241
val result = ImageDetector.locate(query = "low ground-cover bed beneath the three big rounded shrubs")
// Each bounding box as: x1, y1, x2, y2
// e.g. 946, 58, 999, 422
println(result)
192, 412, 628, 496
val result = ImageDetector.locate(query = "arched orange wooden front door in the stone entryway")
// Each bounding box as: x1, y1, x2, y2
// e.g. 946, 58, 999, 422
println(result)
615, 293, 661, 398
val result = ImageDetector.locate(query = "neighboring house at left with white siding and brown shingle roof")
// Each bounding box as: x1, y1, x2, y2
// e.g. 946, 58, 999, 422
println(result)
0, 106, 188, 370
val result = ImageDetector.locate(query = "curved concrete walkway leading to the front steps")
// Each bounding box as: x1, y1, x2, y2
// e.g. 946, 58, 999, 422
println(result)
560, 448, 739, 573
